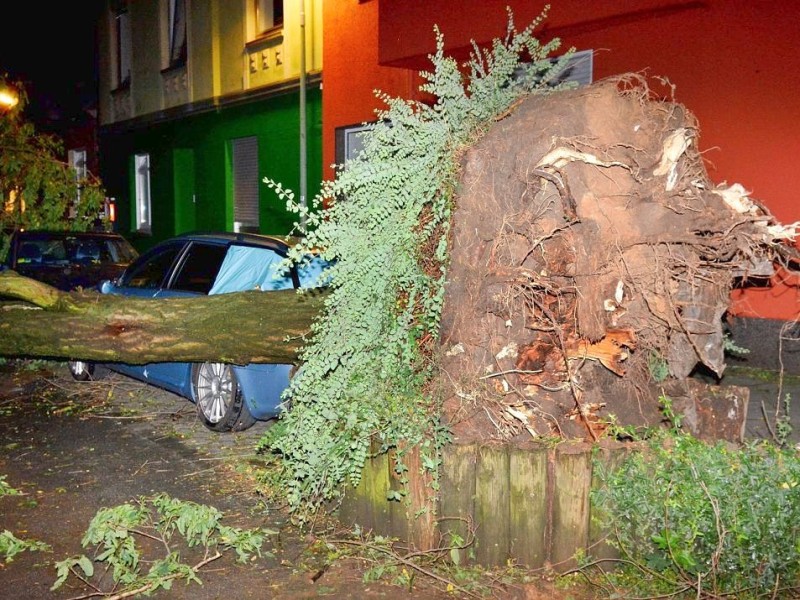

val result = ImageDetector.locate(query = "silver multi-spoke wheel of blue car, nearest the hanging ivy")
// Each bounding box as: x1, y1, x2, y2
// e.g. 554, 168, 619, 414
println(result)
192, 363, 256, 431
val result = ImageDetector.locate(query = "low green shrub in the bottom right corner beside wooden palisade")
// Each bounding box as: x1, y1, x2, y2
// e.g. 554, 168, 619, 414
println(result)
592, 433, 800, 598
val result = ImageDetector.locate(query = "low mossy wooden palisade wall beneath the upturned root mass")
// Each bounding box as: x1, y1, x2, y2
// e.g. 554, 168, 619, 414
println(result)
338, 442, 627, 572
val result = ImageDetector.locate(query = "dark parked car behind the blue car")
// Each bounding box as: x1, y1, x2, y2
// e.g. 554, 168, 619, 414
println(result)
3, 230, 139, 291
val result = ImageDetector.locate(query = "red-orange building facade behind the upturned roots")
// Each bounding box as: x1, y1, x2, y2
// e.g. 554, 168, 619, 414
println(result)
323, 0, 800, 321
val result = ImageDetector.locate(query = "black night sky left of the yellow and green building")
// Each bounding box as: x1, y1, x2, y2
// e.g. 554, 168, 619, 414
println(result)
0, 0, 100, 121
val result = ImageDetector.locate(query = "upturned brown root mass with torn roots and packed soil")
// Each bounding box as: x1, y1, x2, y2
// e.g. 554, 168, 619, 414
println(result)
439, 75, 796, 438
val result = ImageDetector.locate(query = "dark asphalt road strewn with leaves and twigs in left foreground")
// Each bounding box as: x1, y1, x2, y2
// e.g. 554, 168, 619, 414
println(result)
0, 365, 453, 600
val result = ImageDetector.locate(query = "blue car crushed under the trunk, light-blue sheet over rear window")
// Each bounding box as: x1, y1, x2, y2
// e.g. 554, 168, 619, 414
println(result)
69, 233, 328, 431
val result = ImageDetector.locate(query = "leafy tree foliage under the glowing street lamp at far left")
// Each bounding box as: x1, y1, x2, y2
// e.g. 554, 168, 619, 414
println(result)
0, 75, 105, 260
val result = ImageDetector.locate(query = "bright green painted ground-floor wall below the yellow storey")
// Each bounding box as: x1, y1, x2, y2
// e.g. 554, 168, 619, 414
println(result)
100, 87, 322, 250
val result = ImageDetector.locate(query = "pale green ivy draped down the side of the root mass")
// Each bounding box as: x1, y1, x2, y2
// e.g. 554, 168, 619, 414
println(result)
260, 7, 572, 519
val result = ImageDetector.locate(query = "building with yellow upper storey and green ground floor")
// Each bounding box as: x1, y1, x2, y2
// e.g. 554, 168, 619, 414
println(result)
98, 0, 322, 250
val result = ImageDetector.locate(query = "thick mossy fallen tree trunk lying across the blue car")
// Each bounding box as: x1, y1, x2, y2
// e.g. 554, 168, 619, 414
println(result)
0, 271, 324, 364
